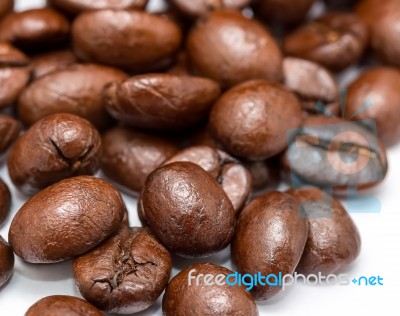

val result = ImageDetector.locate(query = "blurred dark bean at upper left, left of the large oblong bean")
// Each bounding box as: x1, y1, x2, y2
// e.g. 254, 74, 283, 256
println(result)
0, 8, 69, 50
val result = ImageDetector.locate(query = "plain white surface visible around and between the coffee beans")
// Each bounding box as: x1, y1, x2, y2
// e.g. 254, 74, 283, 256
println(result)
0, 0, 400, 316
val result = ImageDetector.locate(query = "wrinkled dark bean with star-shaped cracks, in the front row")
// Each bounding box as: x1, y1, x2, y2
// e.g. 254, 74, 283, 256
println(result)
73, 227, 172, 314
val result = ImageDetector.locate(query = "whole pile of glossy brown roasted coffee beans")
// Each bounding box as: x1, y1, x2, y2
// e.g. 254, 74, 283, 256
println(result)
0, 0, 400, 316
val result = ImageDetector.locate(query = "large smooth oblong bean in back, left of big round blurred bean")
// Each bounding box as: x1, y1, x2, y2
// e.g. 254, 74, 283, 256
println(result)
72, 10, 182, 72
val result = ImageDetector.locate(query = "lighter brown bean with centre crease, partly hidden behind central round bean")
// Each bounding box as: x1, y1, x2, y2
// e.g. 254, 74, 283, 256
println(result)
164, 145, 252, 214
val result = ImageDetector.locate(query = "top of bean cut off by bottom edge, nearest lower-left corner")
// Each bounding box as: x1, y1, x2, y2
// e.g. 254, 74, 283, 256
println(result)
25, 295, 104, 316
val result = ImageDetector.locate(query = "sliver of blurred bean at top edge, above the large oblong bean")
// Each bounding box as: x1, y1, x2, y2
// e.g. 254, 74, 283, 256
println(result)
49, 0, 148, 15
